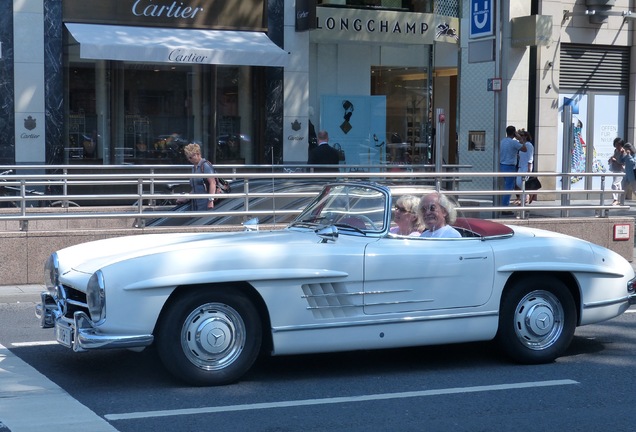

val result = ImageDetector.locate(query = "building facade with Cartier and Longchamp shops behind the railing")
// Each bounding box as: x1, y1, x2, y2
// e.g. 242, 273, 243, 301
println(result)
0, 0, 636, 197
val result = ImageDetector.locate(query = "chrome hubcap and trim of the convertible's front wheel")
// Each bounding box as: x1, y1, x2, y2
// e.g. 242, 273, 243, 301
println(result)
181, 303, 246, 370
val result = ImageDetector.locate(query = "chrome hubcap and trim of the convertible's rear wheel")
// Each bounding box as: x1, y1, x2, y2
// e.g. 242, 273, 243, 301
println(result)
514, 291, 565, 351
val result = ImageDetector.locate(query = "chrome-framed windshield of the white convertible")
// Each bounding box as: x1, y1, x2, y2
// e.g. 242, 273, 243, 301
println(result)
292, 184, 389, 234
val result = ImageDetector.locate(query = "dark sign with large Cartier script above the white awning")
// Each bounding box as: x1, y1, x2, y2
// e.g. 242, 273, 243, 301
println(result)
63, 0, 267, 31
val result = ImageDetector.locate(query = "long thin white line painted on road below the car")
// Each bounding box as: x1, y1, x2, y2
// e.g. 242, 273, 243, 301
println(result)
104, 379, 579, 421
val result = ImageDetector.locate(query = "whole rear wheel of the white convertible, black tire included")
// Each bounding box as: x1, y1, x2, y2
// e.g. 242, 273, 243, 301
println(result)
496, 276, 577, 364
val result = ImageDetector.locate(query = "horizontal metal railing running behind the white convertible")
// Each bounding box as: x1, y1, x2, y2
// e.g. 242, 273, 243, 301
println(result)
0, 165, 629, 230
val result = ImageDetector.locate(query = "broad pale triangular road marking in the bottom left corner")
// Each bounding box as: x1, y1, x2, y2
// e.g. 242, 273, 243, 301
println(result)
0, 345, 117, 432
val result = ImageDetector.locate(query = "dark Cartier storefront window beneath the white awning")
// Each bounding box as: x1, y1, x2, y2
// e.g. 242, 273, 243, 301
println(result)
64, 33, 262, 165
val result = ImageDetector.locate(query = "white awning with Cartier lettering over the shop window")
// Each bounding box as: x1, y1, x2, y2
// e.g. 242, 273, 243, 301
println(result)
66, 23, 289, 66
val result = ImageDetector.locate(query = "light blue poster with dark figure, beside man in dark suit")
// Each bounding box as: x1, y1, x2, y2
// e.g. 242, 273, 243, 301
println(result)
320, 95, 386, 165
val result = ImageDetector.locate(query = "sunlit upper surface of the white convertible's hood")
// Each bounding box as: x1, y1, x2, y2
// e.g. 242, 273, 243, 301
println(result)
58, 230, 318, 274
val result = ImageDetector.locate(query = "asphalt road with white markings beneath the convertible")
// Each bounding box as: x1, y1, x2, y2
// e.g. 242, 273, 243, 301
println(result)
0, 294, 636, 432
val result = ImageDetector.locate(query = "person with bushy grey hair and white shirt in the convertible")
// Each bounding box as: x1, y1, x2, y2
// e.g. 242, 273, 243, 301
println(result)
418, 192, 462, 238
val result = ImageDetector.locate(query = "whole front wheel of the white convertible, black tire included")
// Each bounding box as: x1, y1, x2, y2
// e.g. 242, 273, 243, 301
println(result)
156, 289, 262, 386
